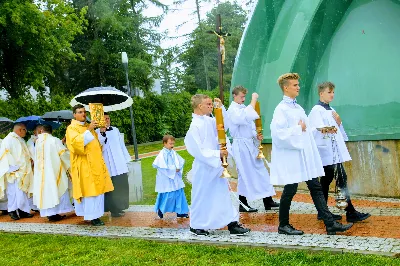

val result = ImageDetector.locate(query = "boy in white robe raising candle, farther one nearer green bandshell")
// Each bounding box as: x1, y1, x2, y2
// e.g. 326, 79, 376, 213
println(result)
227, 86, 279, 212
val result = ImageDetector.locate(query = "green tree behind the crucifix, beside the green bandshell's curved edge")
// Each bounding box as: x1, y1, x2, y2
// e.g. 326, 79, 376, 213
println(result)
180, 2, 246, 94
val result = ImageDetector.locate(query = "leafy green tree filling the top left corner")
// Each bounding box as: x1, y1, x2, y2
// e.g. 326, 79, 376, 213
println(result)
0, 0, 86, 98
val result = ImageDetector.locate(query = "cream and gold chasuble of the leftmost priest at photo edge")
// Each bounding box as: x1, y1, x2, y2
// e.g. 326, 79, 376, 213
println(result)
0, 132, 33, 199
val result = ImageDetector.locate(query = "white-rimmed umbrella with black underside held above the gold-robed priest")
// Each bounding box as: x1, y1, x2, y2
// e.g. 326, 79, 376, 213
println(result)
70, 87, 133, 112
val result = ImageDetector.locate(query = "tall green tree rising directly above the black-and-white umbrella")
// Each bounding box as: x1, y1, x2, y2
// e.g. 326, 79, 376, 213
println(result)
50, 0, 165, 94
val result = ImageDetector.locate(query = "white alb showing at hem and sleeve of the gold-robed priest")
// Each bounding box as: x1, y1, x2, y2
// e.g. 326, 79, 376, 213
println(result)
74, 122, 104, 221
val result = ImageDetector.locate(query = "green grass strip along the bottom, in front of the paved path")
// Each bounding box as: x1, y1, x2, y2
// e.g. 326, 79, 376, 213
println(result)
0, 233, 400, 266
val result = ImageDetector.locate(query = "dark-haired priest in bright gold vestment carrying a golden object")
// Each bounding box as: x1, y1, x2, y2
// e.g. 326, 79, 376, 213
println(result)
66, 104, 114, 226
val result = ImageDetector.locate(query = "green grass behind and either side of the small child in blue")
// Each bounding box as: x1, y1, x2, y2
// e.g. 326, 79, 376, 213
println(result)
132, 150, 193, 205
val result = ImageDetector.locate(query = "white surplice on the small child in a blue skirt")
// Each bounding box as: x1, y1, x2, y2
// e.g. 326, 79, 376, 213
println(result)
153, 148, 185, 193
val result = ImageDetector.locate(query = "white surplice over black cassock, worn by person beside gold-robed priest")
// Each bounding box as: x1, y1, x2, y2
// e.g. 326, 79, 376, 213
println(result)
96, 127, 131, 176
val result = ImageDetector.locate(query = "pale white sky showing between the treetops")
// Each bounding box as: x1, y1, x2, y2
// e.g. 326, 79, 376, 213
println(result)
144, 0, 250, 48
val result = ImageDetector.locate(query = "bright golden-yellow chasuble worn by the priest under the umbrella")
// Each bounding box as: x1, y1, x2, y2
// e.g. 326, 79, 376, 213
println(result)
66, 119, 114, 202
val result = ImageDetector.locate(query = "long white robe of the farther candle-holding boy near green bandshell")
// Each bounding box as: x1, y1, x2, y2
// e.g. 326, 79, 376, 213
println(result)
227, 102, 275, 201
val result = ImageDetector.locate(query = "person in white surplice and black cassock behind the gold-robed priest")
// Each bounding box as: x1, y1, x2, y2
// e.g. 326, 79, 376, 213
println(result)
96, 113, 131, 217
